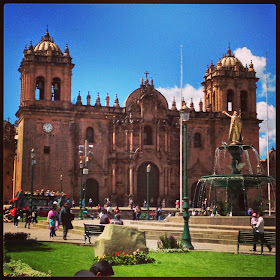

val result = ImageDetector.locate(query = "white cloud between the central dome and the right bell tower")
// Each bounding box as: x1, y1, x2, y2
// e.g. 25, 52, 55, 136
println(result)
157, 84, 204, 111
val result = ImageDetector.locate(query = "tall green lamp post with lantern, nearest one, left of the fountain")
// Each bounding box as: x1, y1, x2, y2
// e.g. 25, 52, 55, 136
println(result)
180, 102, 194, 250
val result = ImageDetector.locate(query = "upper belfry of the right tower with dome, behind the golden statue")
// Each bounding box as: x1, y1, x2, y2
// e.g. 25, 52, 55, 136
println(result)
201, 47, 259, 118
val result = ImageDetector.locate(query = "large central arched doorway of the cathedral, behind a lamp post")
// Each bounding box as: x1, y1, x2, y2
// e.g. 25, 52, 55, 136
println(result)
136, 162, 159, 206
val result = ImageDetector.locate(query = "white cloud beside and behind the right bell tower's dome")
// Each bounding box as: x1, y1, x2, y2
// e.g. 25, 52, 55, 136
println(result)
233, 47, 276, 97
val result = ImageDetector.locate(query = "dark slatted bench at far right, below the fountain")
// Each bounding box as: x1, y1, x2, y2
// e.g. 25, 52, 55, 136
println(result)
237, 230, 276, 253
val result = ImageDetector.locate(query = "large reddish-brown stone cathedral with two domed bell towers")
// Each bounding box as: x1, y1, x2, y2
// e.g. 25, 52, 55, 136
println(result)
14, 30, 261, 207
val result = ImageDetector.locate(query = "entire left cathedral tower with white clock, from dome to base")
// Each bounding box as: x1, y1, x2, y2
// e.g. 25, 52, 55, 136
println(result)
16, 30, 74, 190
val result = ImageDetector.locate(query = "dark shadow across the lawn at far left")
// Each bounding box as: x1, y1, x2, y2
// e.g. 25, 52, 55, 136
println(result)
4, 239, 53, 252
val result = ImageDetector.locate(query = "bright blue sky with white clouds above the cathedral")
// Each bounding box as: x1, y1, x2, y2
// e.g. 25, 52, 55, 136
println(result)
3, 4, 276, 158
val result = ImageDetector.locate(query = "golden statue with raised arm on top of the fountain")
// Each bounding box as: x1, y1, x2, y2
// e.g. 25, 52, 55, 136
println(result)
223, 111, 243, 145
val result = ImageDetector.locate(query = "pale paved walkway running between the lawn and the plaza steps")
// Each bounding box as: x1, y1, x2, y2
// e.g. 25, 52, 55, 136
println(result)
3, 219, 275, 255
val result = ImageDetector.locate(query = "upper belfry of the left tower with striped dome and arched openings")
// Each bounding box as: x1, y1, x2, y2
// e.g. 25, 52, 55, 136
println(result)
19, 30, 74, 108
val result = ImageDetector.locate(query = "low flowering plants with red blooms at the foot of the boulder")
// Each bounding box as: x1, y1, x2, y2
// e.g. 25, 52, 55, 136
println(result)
98, 249, 155, 265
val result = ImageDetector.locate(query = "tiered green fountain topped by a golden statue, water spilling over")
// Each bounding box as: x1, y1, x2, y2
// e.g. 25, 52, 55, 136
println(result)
192, 112, 275, 215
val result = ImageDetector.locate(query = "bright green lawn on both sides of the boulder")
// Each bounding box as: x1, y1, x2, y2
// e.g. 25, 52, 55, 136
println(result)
6, 242, 276, 277
